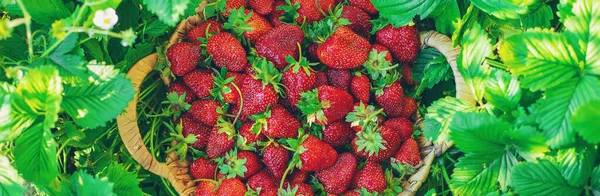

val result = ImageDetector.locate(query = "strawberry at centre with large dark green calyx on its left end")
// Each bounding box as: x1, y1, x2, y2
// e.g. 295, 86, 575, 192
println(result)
298, 86, 353, 125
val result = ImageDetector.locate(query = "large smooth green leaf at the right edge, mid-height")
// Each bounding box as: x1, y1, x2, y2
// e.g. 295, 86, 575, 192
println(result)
534, 76, 600, 147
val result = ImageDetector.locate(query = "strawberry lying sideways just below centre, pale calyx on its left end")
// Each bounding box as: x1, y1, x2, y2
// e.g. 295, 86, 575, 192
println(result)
250, 105, 301, 138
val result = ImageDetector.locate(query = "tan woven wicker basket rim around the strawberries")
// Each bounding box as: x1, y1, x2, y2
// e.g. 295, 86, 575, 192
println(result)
117, 1, 475, 196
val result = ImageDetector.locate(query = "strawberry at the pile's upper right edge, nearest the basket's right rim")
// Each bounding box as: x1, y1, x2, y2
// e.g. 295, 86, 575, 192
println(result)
375, 25, 421, 62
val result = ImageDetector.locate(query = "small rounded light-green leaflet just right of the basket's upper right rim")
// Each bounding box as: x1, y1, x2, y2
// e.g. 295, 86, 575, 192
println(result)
484, 69, 521, 112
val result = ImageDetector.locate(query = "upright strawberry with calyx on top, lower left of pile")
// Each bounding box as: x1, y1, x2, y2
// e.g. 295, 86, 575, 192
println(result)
206, 117, 235, 159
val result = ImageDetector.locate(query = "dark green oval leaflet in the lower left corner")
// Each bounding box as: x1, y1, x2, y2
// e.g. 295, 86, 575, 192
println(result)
13, 123, 58, 186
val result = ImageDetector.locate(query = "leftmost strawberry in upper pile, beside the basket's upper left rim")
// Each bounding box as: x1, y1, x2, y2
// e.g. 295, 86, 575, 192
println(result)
167, 42, 202, 76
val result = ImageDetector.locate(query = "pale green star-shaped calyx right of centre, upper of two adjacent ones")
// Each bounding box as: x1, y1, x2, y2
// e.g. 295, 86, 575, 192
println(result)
346, 102, 385, 132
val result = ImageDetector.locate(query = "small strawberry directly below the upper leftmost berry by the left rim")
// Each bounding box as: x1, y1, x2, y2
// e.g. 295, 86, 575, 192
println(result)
183, 69, 214, 99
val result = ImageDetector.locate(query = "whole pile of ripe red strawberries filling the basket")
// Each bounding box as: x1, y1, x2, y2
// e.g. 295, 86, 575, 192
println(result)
167, 0, 421, 196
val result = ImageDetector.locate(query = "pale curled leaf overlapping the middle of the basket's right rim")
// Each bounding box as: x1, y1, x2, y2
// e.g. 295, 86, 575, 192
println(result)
423, 97, 477, 142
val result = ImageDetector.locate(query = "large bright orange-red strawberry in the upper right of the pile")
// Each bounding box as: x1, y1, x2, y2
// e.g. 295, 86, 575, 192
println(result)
317, 26, 371, 69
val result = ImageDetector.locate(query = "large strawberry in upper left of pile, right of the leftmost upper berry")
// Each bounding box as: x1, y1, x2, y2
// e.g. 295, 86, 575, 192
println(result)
206, 32, 248, 72
